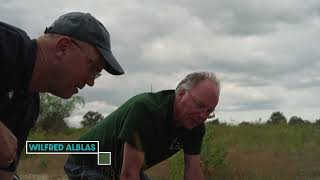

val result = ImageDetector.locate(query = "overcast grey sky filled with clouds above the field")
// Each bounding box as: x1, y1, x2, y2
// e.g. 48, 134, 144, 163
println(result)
0, 0, 320, 125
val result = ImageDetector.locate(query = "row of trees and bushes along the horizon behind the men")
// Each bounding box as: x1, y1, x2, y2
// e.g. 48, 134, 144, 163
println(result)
34, 93, 320, 132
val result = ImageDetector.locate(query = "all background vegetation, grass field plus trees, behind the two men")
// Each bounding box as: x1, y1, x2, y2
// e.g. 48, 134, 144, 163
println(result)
18, 94, 320, 179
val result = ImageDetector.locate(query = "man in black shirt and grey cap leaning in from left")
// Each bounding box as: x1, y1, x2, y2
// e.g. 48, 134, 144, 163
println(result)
0, 12, 124, 179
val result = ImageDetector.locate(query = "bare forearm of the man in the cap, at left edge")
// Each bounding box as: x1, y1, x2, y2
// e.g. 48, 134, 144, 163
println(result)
0, 121, 18, 168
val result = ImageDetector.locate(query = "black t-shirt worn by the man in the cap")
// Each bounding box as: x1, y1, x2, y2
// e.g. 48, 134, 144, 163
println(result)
0, 22, 39, 171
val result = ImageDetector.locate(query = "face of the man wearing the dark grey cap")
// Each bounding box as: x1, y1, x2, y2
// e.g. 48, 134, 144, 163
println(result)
51, 38, 105, 99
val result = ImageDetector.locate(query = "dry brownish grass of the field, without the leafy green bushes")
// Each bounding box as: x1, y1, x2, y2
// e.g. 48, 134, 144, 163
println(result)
18, 126, 320, 180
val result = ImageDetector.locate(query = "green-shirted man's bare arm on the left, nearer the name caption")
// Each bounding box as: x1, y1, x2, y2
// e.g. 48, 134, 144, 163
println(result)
120, 143, 144, 180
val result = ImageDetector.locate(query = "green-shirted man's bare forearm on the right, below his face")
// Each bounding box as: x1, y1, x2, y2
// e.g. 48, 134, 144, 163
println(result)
184, 154, 204, 180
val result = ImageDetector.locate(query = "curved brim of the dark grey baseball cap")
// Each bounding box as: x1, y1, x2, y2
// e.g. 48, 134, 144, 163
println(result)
96, 46, 124, 75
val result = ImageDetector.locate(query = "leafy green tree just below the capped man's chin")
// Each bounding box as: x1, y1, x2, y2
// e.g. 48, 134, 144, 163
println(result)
36, 93, 84, 131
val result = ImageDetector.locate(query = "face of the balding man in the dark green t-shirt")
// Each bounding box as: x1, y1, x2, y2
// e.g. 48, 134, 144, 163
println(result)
177, 80, 219, 129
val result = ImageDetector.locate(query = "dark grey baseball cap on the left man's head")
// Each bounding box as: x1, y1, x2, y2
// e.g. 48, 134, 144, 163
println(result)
44, 12, 124, 75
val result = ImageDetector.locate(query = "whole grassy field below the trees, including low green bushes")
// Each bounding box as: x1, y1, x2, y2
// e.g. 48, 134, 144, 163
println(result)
18, 123, 320, 180
